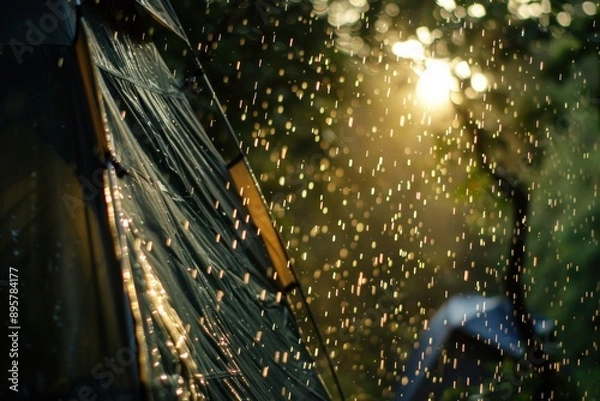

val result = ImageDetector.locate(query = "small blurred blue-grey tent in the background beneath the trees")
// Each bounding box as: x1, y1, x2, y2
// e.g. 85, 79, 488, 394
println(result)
396, 294, 554, 401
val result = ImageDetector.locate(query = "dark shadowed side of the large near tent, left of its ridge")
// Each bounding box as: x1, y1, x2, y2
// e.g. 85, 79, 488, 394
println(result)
0, 1, 141, 400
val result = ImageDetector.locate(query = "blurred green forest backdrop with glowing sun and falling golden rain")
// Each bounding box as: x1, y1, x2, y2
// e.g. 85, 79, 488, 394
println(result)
154, 0, 600, 400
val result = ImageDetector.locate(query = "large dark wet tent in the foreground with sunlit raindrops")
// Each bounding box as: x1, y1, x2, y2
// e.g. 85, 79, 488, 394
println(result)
0, 0, 330, 400
